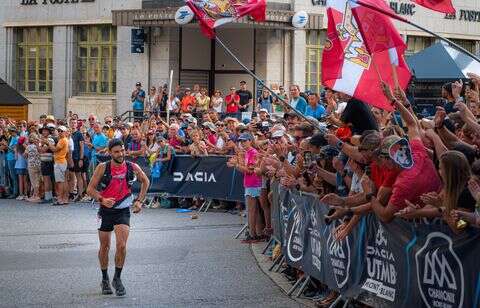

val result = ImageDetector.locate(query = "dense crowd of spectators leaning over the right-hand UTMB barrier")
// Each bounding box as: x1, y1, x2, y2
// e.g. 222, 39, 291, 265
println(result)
228, 74, 480, 307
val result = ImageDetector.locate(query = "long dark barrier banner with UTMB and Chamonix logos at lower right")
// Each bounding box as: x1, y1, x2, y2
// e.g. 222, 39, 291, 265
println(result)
272, 183, 480, 308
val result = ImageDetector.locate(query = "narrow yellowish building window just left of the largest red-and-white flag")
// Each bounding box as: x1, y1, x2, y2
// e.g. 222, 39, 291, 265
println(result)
305, 30, 326, 93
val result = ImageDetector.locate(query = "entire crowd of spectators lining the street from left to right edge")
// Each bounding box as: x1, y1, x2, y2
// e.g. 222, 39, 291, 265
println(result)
0, 74, 480, 229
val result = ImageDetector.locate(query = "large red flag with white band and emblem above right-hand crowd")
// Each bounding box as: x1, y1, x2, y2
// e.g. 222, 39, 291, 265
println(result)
322, 0, 411, 111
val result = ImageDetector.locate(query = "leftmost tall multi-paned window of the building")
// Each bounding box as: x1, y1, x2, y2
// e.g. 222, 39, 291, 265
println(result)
16, 27, 53, 93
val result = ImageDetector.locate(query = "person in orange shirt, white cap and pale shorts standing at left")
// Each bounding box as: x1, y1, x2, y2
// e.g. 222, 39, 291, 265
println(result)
50, 126, 69, 205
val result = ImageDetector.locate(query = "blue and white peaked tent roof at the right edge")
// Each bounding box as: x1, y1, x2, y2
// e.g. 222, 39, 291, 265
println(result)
407, 42, 480, 82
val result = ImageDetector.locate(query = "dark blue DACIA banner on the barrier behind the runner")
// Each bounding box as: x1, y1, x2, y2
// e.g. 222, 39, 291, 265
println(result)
149, 155, 244, 202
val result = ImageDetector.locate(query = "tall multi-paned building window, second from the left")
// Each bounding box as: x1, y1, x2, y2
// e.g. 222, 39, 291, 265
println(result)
77, 25, 117, 95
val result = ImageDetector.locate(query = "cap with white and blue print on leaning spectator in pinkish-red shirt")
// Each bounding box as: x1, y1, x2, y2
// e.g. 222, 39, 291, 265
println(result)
379, 135, 414, 169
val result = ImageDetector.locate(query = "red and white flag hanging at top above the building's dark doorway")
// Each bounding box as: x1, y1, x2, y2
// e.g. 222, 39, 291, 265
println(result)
186, 0, 267, 39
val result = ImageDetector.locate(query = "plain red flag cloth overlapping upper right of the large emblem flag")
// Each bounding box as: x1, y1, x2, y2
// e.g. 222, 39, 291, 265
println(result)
349, 0, 407, 54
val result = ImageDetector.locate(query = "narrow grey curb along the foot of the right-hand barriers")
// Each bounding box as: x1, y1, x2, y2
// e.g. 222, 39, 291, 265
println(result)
250, 242, 315, 308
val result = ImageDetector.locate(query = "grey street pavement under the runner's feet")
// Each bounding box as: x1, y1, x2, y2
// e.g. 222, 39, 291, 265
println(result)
0, 200, 300, 307
